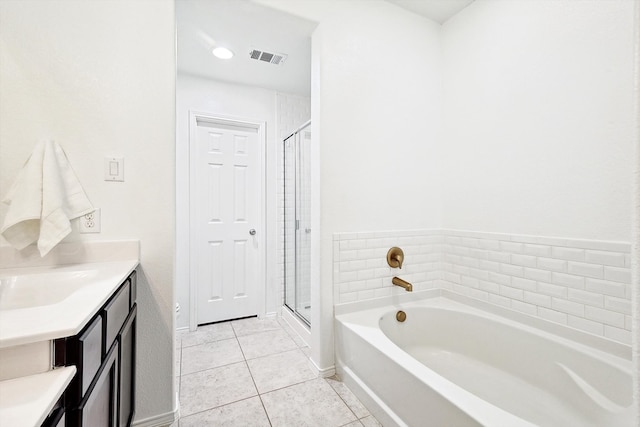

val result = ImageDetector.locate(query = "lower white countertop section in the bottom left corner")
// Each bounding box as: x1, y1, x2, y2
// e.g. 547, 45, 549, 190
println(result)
0, 366, 76, 427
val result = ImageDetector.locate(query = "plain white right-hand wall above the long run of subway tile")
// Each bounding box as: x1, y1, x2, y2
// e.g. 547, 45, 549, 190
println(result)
443, 0, 637, 242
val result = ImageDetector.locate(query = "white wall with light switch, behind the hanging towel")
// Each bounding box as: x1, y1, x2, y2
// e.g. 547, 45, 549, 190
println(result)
0, 0, 175, 420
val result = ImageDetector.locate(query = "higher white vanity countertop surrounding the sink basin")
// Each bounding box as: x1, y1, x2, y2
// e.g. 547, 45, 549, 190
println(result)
0, 260, 138, 348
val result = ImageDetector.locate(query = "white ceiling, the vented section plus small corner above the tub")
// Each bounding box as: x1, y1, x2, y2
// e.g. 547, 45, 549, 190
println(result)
176, 0, 474, 96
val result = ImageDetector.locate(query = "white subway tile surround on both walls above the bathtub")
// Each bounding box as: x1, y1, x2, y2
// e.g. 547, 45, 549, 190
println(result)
334, 230, 631, 344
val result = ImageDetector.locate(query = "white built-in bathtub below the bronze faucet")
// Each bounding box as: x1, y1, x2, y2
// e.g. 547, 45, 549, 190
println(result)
335, 291, 633, 427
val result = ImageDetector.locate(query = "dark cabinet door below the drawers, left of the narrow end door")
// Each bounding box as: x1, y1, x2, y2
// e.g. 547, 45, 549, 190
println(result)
79, 344, 119, 427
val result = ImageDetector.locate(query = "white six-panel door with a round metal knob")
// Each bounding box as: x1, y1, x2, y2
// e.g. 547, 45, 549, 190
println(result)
191, 118, 263, 324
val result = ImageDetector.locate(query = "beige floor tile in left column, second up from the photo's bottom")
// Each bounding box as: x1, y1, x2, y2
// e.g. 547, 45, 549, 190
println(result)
180, 362, 258, 416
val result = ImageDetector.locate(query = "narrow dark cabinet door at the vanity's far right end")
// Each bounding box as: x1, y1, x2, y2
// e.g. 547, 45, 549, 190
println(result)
119, 304, 138, 427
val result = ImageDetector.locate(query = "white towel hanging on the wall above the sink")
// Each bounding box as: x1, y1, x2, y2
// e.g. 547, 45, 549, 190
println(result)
0, 141, 95, 256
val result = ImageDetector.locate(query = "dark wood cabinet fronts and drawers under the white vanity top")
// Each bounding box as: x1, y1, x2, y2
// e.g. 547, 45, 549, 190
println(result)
57, 271, 138, 427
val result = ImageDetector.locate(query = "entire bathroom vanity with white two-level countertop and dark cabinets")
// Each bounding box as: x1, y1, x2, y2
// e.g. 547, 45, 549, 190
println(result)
0, 242, 138, 427
